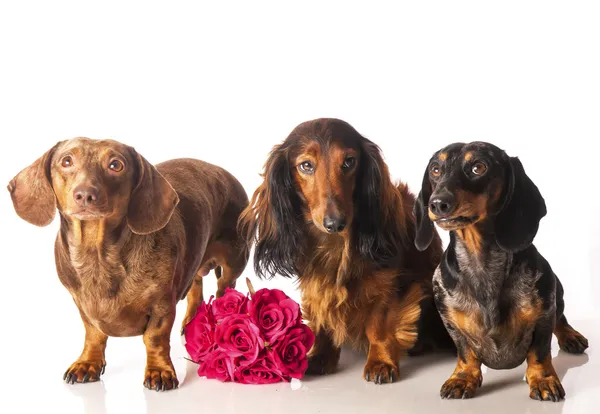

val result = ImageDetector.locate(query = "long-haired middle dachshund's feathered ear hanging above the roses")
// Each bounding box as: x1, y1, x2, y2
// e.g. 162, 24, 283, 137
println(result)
238, 144, 304, 278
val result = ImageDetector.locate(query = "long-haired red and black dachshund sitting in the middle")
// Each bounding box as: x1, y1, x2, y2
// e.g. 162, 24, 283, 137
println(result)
240, 119, 452, 384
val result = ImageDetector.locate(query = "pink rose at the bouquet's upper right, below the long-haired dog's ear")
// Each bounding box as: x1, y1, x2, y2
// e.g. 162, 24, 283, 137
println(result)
248, 289, 301, 344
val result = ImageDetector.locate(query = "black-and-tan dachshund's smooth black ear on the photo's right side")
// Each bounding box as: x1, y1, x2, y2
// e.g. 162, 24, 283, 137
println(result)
494, 157, 546, 252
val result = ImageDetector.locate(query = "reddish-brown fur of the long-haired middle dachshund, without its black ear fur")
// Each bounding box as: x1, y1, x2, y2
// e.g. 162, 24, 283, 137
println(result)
240, 120, 445, 382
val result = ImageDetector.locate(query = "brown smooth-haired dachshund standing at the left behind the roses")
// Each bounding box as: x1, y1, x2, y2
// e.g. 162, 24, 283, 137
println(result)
8, 137, 249, 391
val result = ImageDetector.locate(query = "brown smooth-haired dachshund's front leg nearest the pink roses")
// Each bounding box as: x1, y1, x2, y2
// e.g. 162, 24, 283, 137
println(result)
144, 298, 179, 391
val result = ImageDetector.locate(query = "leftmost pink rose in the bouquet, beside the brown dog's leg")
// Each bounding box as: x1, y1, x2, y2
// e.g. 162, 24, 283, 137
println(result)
184, 302, 215, 362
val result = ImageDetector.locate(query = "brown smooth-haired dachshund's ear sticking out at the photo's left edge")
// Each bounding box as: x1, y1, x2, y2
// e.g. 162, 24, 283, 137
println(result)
7, 142, 60, 227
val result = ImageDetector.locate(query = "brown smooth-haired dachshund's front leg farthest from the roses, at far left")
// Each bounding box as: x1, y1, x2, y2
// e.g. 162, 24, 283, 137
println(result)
63, 310, 108, 384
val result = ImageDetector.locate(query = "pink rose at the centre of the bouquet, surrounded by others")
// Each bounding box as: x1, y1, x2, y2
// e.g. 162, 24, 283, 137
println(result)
215, 315, 265, 366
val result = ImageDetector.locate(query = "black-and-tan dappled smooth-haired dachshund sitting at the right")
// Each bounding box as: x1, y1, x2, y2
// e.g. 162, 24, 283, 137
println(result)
415, 142, 588, 401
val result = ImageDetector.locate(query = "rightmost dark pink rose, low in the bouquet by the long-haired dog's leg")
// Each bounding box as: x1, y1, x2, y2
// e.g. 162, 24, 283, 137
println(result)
273, 323, 315, 379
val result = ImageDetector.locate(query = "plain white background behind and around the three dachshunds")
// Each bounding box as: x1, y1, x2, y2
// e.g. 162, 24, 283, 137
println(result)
0, 1, 600, 412
